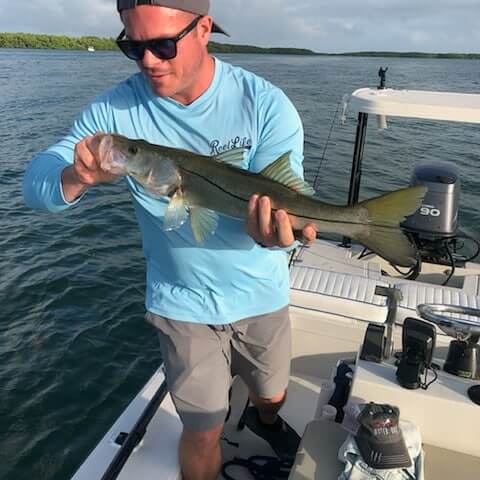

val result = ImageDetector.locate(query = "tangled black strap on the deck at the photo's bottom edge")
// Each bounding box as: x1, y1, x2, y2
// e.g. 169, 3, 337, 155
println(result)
222, 455, 293, 480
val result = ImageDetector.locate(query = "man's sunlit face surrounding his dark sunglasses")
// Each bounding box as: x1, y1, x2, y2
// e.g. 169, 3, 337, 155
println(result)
122, 5, 211, 104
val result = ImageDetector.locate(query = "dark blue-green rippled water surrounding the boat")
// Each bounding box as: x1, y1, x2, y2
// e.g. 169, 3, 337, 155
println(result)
0, 50, 480, 480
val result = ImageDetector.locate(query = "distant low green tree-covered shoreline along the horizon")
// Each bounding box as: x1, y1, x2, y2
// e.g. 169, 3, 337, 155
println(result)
0, 32, 480, 60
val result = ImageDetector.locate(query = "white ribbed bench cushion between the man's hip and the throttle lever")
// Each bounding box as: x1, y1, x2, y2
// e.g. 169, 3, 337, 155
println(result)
290, 265, 389, 323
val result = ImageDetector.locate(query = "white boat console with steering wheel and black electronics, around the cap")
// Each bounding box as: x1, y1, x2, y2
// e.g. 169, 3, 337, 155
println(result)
289, 304, 480, 480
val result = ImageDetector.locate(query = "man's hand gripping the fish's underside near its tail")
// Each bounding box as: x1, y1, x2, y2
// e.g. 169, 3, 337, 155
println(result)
247, 194, 317, 248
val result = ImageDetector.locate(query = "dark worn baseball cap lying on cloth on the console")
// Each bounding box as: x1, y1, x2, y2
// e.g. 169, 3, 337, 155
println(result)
355, 402, 412, 470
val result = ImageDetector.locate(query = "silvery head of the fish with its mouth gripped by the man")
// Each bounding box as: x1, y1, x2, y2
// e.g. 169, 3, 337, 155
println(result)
99, 134, 181, 196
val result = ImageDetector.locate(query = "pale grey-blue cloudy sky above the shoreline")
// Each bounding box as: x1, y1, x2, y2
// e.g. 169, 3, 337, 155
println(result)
0, 0, 480, 53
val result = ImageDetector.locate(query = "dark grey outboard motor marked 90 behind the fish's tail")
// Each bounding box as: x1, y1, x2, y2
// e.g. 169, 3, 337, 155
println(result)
402, 162, 460, 240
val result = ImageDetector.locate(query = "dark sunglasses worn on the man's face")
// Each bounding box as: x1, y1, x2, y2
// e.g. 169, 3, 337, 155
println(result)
116, 15, 202, 62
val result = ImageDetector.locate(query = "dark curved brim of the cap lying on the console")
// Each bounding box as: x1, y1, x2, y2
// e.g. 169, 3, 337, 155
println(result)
355, 431, 412, 470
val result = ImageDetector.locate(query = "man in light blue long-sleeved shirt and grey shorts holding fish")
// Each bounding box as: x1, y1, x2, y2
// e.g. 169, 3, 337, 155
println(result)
24, 0, 316, 480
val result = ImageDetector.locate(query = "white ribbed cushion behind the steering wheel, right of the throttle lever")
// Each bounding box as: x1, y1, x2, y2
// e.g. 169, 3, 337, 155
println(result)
395, 283, 480, 322
